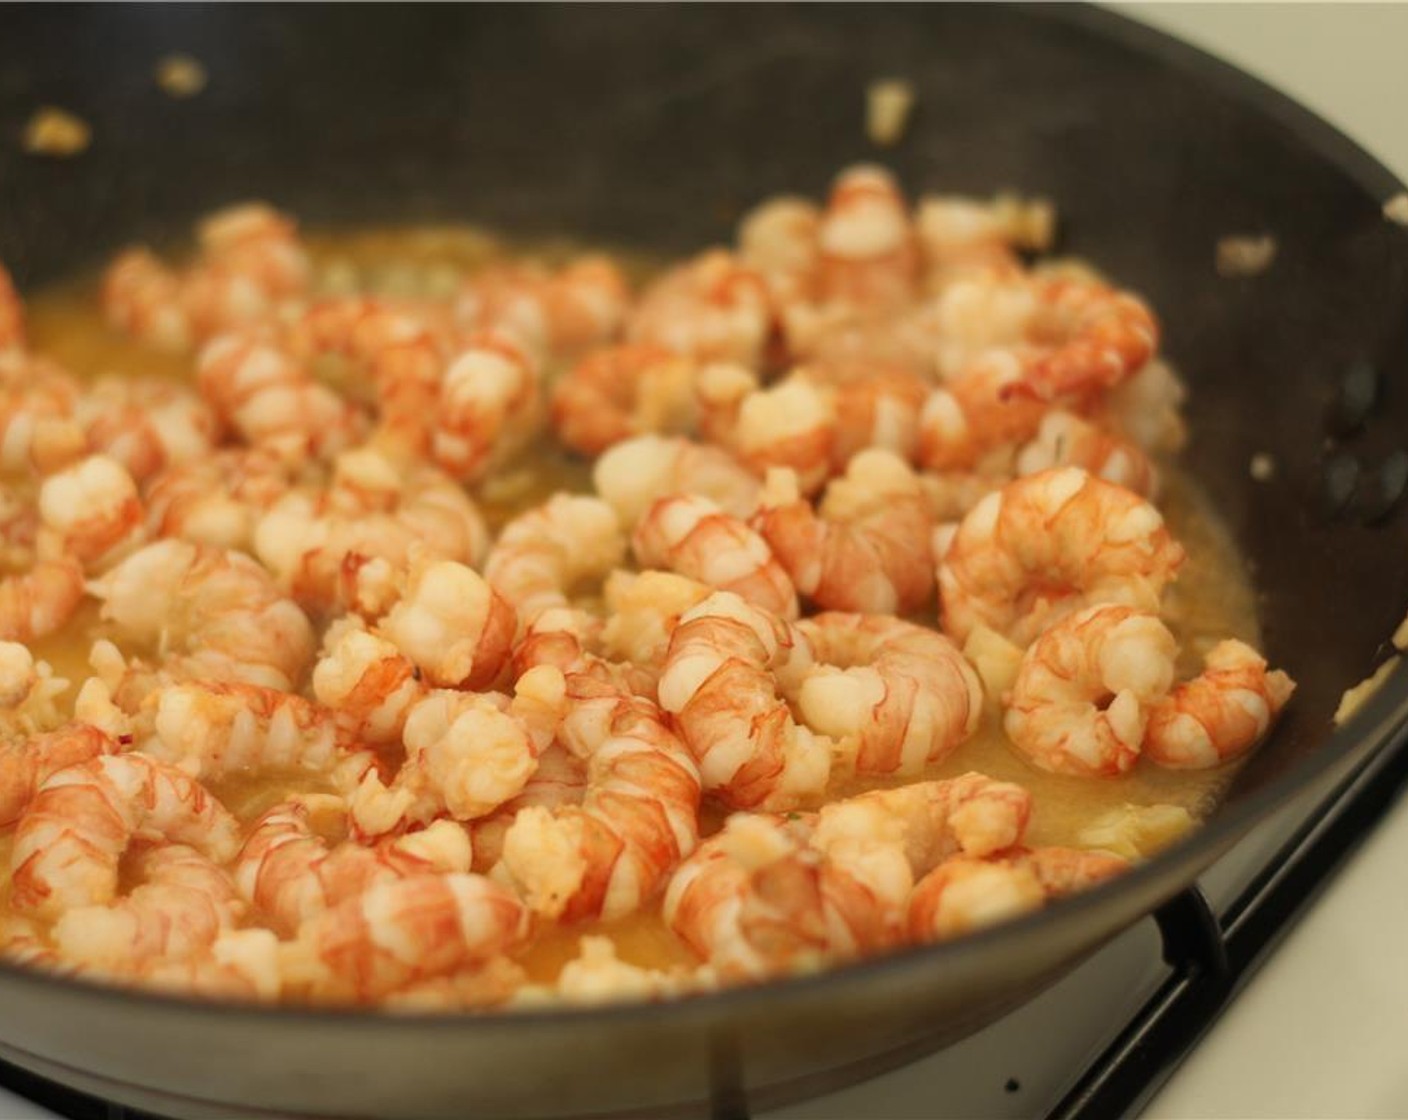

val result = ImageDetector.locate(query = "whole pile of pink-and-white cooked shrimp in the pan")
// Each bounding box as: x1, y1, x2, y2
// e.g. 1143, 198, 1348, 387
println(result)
0, 166, 1294, 1009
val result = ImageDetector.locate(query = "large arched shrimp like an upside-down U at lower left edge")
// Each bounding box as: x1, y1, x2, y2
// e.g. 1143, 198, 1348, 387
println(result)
10, 754, 239, 917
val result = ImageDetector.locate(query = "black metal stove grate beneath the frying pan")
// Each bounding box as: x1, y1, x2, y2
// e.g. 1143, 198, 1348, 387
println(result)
0, 742, 1408, 1120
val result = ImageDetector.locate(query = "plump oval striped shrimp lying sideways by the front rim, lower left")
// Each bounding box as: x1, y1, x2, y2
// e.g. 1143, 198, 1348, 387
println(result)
283, 873, 528, 1003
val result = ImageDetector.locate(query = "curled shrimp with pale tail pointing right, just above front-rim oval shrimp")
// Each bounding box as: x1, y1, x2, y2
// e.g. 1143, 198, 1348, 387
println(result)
234, 796, 470, 935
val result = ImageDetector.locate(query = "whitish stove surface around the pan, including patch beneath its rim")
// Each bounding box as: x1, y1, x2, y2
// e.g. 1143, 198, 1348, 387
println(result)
0, 3, 1408, 1120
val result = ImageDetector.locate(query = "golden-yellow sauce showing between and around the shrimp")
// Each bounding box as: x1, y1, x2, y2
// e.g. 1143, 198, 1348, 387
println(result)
0, 227, 1260, 982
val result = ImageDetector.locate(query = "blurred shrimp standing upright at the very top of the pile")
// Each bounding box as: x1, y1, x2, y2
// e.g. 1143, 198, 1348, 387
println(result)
817, 163, 919, 309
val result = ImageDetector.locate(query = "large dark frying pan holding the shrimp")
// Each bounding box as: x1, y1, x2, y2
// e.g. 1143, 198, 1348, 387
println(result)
0, 6, 1408, 1117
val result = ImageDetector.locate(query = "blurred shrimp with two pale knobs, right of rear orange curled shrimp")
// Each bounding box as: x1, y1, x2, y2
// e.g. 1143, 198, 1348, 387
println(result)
697, 365, 836, 493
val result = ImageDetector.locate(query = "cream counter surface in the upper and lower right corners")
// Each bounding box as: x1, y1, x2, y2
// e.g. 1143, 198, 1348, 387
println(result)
1114, 4, 1408, 1120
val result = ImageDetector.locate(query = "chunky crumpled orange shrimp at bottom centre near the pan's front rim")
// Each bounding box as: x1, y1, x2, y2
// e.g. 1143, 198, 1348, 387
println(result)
663, 813, 898, 979
